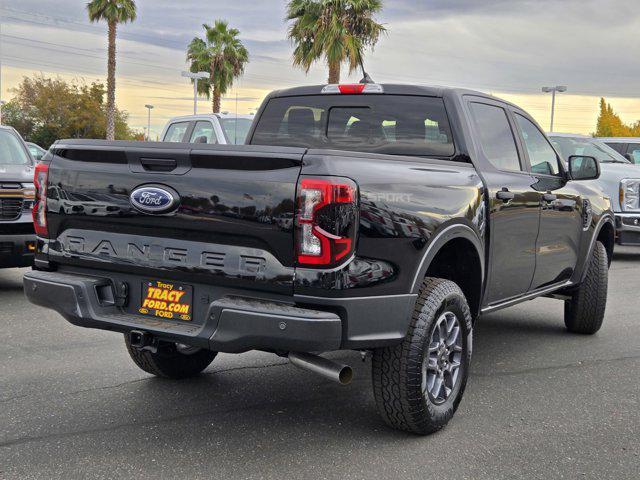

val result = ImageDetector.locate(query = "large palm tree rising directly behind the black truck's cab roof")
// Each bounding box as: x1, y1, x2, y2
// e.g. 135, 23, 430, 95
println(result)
286, 0, 386, 83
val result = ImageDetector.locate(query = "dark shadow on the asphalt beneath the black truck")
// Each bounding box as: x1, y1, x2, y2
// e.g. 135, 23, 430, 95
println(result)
52, 302, 584, 444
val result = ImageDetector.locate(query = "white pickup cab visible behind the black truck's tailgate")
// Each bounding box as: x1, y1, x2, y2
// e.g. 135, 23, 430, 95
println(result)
160, 112, 254, 145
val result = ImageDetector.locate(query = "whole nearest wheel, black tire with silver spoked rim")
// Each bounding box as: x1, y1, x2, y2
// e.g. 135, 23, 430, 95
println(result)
372, 278, 472, 435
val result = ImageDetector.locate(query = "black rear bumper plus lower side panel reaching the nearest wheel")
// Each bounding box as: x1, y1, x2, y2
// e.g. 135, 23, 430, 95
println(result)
24, 270, 416, 353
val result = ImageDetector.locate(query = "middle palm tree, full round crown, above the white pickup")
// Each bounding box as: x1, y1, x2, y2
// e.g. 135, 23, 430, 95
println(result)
187, 20, 249, 113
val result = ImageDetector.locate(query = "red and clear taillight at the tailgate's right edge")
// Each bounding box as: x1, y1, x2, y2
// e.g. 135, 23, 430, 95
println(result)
296, 177, 358, 268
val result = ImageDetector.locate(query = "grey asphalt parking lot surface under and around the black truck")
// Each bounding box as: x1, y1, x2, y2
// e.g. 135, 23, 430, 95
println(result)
0, 248, 640, 479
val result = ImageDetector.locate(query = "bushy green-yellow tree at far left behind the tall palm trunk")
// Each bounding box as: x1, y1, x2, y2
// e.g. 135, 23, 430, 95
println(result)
2, 75, 141, 148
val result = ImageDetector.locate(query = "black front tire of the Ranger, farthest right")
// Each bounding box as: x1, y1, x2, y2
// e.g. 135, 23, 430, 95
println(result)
564, 242, 609, 335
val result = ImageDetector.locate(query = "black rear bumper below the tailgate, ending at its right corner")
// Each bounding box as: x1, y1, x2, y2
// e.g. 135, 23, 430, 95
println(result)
24, 271, 342, 353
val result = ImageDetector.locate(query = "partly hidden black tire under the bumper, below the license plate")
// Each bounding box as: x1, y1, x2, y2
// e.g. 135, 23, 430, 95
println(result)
124, 334, 218, 379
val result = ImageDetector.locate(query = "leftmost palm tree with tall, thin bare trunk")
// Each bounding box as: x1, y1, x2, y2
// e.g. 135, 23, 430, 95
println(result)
87, 0, 136, 140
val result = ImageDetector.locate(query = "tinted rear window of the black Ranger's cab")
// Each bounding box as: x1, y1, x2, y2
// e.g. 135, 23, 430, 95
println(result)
251, 95, 454, 157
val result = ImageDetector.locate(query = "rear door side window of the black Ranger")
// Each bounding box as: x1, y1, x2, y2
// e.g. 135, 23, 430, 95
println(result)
471, 103, 522, 171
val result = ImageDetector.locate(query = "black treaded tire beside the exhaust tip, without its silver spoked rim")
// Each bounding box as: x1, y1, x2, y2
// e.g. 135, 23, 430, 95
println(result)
372, 278, 473, 435
